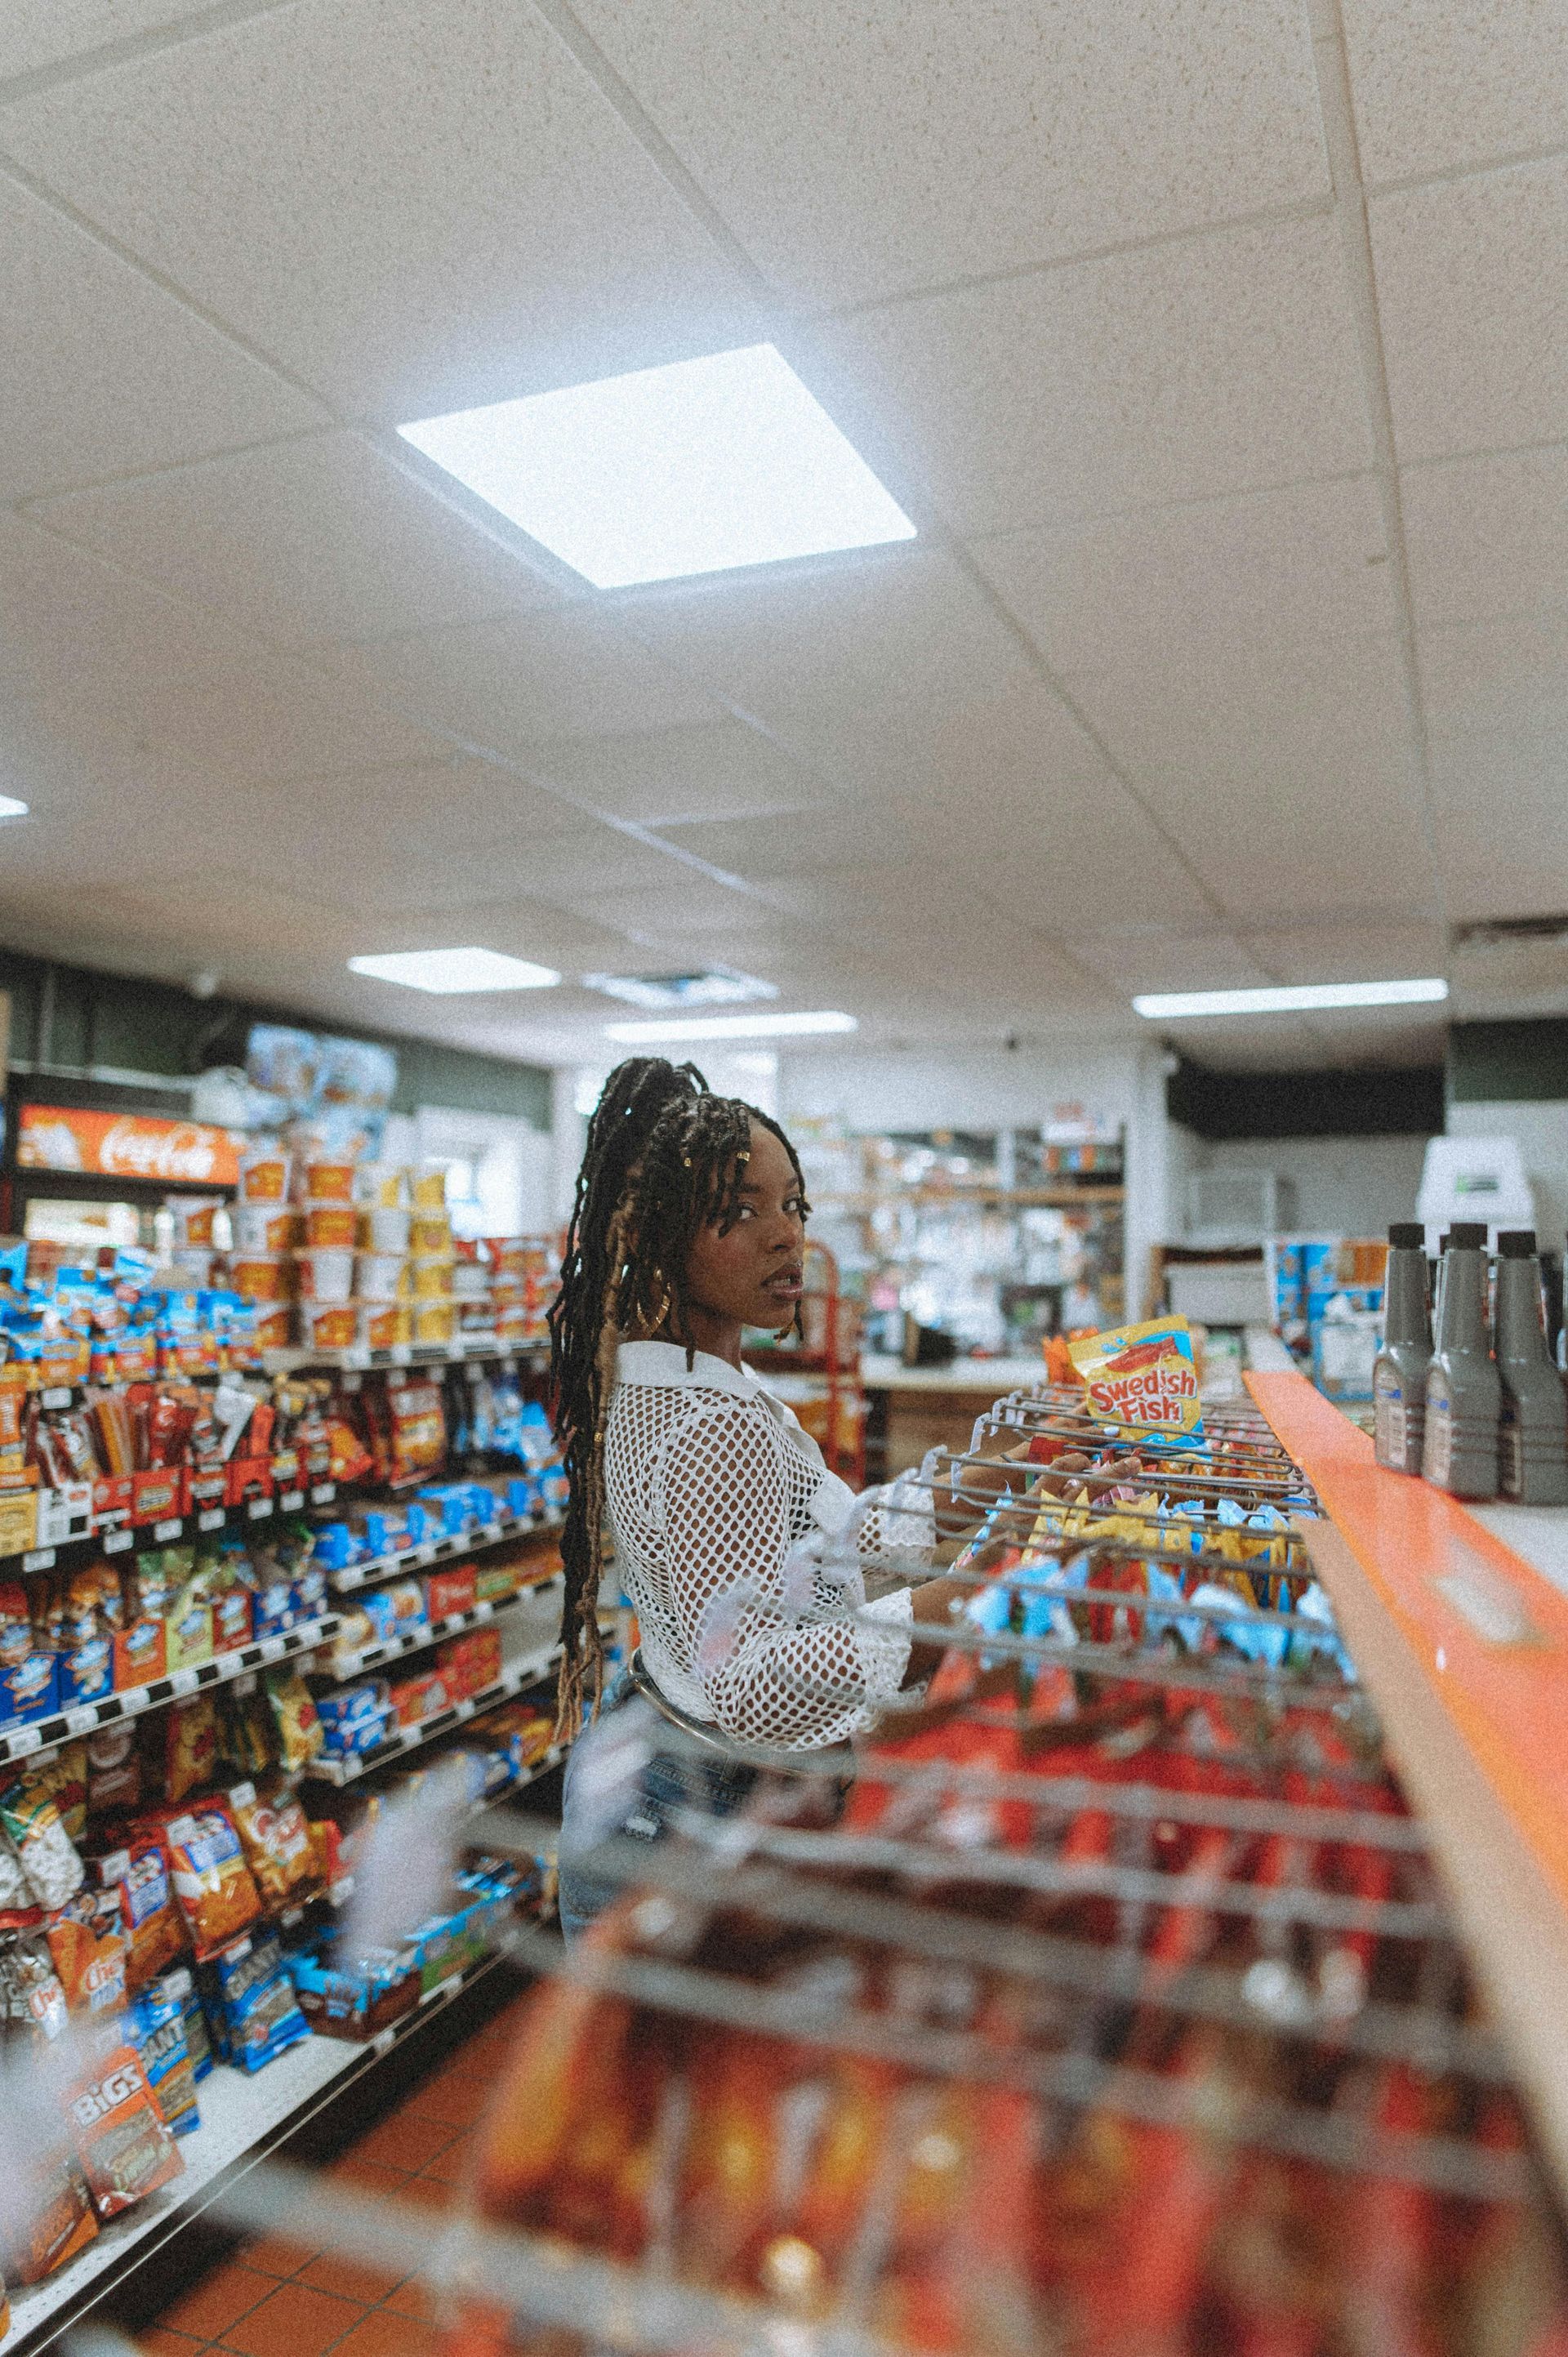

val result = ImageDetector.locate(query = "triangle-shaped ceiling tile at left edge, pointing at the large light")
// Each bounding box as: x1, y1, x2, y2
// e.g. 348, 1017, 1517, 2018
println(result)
0, 172, 323, 500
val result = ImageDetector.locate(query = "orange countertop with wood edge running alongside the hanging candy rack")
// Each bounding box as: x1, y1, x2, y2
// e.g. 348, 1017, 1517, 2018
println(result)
1247, 1375, 1568, 2185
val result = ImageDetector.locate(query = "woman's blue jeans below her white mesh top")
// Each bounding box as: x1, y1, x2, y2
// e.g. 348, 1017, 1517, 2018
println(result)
559, 1669, 757, 1940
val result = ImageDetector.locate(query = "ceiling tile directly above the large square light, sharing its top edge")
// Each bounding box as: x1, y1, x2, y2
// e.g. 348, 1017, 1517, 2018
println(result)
0, 0, 757, 422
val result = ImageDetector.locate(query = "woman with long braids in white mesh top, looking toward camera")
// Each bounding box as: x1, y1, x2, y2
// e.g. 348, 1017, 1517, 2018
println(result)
550, 1058, 1013, 1937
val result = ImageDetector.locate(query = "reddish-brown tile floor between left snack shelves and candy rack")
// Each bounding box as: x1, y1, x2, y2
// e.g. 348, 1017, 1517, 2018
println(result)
136, 1998, 523, 2357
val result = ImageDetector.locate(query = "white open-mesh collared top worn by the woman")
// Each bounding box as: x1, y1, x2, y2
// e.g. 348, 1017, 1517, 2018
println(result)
604, 1341, 933, 1751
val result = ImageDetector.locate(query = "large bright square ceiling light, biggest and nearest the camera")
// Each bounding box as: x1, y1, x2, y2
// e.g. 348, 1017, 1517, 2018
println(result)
399, 344, 915, 590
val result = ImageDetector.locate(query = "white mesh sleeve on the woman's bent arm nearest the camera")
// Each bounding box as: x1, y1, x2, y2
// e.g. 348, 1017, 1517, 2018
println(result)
658, 1400, 910, 1749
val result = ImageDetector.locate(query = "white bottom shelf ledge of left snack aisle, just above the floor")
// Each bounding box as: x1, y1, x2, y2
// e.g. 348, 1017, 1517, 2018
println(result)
5, 1954, 502, 2357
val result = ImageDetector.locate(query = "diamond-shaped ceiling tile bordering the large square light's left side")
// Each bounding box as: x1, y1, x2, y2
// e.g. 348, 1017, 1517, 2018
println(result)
33, 434, 559, 648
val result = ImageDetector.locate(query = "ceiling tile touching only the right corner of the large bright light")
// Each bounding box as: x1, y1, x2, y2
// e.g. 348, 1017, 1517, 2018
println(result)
973, 476, 1398, 672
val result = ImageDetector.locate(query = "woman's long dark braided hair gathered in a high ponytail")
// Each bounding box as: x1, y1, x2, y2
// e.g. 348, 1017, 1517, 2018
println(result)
550, 1056, 802, 1735
